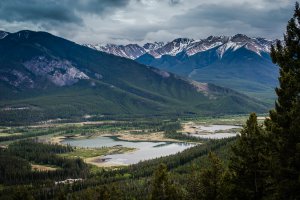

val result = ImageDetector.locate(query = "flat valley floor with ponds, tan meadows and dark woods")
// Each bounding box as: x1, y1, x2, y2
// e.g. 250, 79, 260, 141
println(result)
0, 115, 264, 198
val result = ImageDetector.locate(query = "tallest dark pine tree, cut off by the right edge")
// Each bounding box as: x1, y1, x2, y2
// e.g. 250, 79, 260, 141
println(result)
265, 3, 300, 199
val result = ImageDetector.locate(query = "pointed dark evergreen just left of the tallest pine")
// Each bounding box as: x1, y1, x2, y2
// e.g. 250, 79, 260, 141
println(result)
229, 113, 271, 200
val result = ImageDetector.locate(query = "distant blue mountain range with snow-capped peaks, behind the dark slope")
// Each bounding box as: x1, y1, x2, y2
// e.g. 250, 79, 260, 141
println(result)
85, 34, 279, 103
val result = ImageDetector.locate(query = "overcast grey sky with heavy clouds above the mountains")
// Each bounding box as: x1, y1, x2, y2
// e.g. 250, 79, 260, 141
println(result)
0, 0, 295, 44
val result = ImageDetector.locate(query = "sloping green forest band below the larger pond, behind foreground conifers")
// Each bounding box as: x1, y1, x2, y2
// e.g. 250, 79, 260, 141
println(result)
44, 138, 235, 199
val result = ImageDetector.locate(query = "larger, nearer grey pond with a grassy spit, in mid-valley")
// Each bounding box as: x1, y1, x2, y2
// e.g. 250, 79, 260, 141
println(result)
62, 136, 194, 165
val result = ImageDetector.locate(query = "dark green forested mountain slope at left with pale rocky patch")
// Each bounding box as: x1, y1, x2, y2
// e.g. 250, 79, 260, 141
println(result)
0, 31, 267, 123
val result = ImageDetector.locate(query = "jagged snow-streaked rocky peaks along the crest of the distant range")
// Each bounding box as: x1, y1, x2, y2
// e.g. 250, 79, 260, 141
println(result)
85, 34, 274, 59
